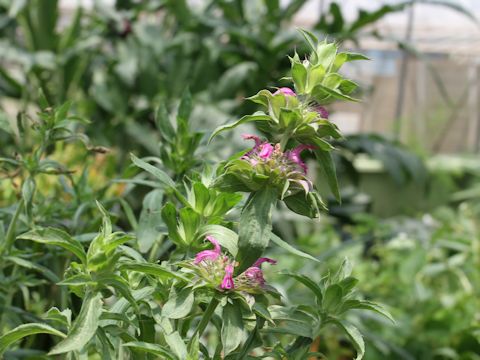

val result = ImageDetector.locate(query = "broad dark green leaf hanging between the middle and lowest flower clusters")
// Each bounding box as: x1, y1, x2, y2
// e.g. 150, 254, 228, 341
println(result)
236, 186, 277, 273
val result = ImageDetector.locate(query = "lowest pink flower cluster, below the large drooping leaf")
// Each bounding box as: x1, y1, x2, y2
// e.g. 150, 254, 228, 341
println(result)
193, 236, 277, 294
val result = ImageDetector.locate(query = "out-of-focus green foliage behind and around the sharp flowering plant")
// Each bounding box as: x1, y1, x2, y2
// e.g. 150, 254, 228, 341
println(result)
0, 0, 480, 359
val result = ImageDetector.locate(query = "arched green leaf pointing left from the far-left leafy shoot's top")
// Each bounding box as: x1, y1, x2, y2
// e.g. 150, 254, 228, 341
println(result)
18, 227, 87, 264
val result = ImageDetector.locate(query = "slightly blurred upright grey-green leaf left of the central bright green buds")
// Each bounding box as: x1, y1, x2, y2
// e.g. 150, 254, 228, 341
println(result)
136, 189, 163, 253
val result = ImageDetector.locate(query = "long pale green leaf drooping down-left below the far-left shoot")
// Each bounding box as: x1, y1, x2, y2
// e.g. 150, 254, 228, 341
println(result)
48, 292, 102, 355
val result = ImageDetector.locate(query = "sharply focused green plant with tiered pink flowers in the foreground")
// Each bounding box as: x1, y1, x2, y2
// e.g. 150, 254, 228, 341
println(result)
0, 32, 390, 360
